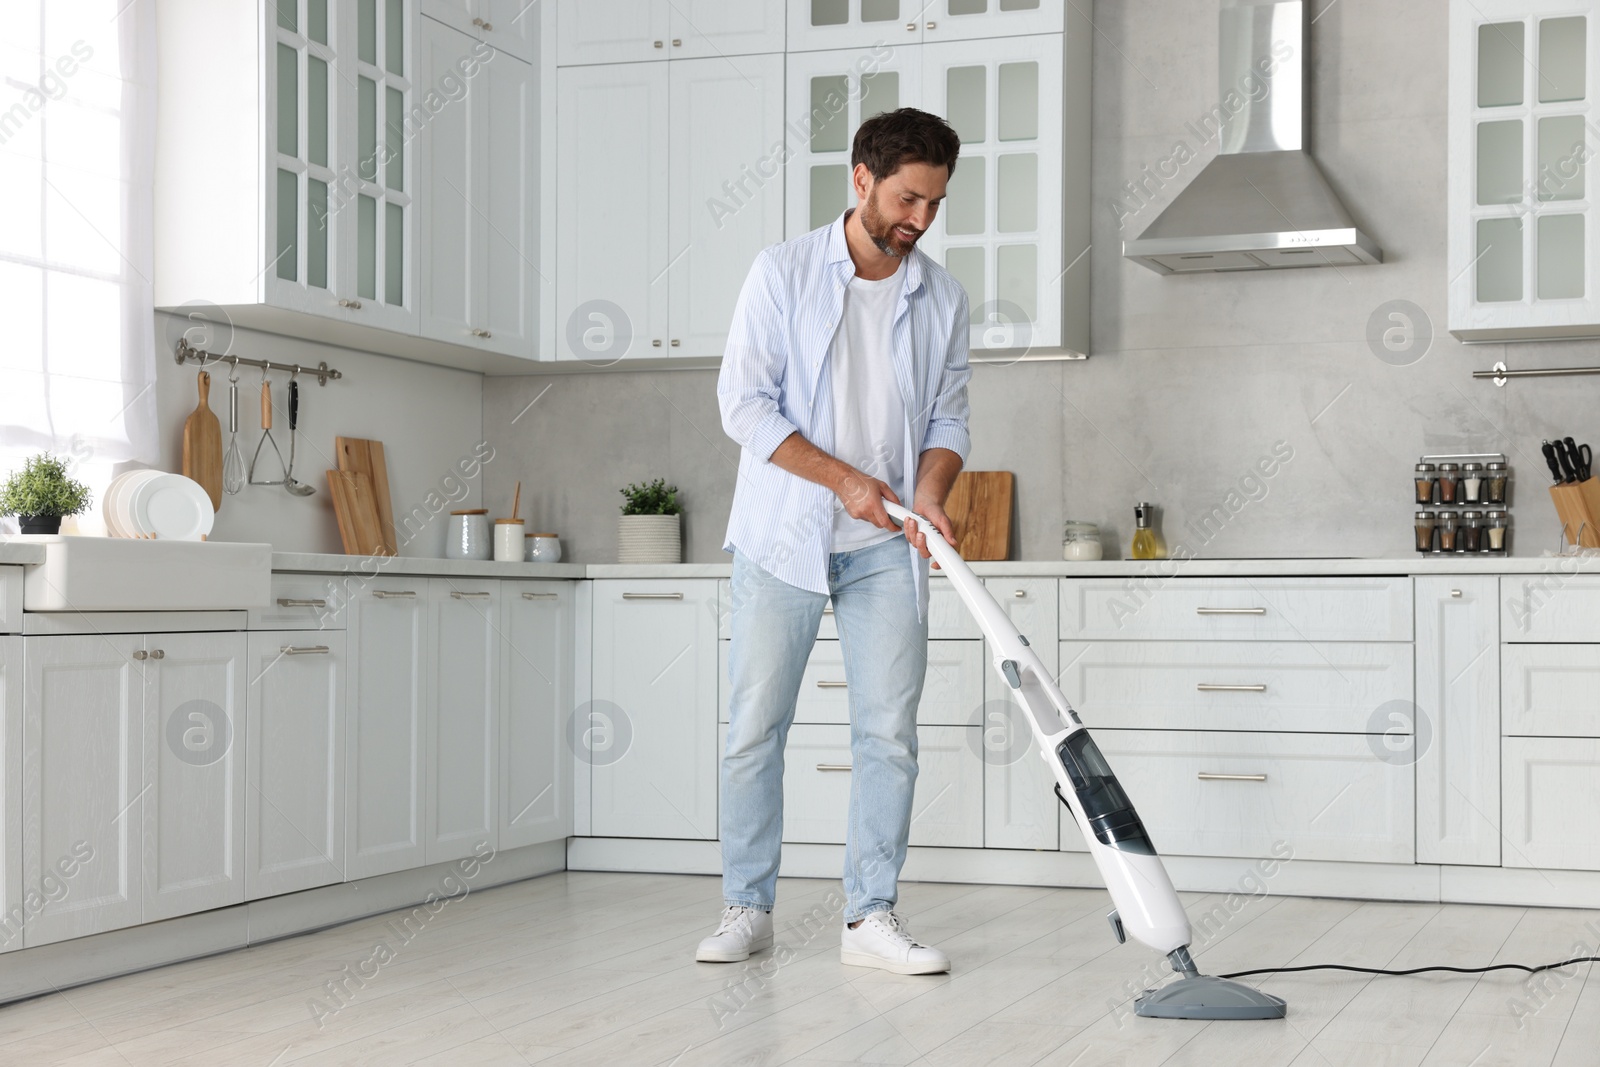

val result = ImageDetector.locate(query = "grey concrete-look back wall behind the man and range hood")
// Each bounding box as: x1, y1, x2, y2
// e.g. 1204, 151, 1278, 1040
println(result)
483, 0, 1600, 561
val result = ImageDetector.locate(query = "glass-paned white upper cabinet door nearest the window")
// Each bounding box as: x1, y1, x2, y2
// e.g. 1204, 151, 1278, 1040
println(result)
262, 0, 347, 315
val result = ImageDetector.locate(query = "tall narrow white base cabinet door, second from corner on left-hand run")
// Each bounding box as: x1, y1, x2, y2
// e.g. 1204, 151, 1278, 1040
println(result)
424, 577, 502, 864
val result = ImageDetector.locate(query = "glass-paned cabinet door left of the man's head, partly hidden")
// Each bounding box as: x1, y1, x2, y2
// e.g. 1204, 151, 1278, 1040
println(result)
784, 45, 928, 242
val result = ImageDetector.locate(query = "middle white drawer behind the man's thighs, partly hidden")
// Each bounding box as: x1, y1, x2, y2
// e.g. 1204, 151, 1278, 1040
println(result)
717, 641, 984, 726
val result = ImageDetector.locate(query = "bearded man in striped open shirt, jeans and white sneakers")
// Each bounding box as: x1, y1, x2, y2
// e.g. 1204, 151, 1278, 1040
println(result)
694, 107, 971, 974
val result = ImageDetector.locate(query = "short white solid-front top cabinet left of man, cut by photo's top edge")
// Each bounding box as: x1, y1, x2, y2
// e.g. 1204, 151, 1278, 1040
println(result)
555, 0, 784, 67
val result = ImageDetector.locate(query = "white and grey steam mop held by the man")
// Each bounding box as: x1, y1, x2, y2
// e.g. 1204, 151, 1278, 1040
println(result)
883, 501, 1288, 1019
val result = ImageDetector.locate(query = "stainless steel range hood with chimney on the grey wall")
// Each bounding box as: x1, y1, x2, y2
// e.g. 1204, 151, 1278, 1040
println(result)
1122, 0, 1384, 274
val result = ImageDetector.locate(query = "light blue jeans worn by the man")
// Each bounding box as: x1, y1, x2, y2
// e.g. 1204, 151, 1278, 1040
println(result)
720, 537, 928, 923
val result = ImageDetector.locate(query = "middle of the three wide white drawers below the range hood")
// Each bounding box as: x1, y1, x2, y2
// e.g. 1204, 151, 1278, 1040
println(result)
1061, 641, 1413, 733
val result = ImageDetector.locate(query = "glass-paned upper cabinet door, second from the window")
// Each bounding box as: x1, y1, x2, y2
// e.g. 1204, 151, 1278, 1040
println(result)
339, 0, 424, 330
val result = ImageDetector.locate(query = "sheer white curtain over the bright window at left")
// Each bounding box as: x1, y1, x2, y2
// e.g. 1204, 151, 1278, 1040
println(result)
0, 0, 158, 525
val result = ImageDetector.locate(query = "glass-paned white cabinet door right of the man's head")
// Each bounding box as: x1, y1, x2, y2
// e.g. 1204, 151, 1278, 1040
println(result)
920, 33, 1066, 350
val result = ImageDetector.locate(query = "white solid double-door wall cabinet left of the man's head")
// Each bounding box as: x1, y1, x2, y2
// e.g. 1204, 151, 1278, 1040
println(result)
552, 54, 784, 365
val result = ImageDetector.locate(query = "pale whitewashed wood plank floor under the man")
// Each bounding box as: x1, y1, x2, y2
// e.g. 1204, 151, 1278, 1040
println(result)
0, 872, 1600, 1067
